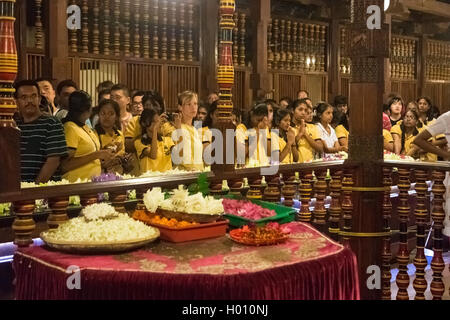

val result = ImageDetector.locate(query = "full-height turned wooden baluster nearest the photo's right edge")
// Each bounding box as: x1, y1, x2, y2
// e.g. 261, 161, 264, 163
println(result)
430, 171, 445, 300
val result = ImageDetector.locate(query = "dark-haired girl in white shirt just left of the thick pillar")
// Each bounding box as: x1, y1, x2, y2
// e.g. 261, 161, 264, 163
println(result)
314, 103, 348, 154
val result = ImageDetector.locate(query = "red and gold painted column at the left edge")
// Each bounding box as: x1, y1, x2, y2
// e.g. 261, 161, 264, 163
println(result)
0, 0, 18, 127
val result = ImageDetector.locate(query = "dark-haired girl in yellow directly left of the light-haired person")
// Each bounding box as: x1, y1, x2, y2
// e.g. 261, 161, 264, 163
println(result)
134, 109, 175, 174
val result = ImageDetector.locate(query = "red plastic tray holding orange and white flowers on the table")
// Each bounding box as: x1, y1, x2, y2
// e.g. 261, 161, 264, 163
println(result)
149, 220, 228, 242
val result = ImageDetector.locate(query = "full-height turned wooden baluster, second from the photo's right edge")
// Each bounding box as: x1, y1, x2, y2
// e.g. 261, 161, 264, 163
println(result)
414, 169, 428, 300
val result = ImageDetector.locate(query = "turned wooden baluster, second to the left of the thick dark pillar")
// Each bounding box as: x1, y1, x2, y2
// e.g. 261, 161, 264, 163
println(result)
328, 170, 342, 241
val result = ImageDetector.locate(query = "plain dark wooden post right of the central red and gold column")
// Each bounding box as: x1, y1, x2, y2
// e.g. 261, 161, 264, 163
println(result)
250, 0, 272, 99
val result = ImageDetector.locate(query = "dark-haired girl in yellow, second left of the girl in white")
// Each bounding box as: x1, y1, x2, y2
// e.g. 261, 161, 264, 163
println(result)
272, 109, 299, 164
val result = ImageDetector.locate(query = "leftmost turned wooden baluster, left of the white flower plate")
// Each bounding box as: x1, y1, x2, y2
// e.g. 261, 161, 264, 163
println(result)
12, 200, 36, 247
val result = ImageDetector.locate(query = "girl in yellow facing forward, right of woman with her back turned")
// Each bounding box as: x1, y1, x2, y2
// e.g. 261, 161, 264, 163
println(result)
95, 100, 125, 174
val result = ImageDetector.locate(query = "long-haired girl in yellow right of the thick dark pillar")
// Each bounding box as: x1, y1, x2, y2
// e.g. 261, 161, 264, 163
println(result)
391, 110, 419, 157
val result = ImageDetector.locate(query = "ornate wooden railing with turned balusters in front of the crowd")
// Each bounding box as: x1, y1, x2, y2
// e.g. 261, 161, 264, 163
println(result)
0, 161, 450, 300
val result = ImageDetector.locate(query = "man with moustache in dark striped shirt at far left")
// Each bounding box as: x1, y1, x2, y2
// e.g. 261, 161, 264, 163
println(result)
14, 80, 67, 184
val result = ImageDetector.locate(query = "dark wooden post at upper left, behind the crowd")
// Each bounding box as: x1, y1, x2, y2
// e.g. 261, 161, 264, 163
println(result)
44, 0, 72, 81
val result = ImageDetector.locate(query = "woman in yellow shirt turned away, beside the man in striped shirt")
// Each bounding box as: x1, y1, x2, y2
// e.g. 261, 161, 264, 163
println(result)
61, 91, 113, 182
